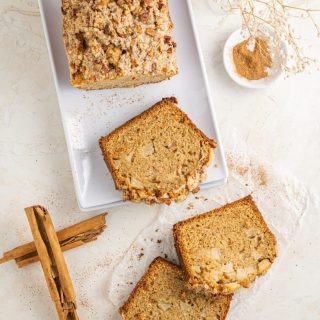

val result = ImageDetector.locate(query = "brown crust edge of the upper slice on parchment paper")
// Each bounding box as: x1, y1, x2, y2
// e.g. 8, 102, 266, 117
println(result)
173, 195, 277, 295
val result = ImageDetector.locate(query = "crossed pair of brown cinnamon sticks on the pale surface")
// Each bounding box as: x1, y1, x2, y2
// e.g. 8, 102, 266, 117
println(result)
0, 206, 106, 320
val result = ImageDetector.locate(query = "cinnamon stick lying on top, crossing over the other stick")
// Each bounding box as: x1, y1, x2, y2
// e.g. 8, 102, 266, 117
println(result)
25, 206, 79, 320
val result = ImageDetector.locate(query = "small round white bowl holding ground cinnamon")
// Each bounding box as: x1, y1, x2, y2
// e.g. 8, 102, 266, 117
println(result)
223, 29, 286, 89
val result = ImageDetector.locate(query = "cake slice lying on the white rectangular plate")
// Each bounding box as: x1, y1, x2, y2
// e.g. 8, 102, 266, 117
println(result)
100, 98, 216, 204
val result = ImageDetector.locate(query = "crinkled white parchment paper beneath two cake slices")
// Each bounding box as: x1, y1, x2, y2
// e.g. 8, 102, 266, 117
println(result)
108, 146, 310, 320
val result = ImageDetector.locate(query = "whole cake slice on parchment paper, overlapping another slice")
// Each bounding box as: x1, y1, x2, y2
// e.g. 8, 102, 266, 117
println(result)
173, 196, 277, 294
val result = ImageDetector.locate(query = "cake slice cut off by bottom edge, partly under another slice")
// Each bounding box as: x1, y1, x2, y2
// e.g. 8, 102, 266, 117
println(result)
119, 258, 231, 320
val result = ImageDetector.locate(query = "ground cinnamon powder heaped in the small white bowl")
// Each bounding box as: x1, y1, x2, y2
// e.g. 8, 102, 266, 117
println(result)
232, 38, 272, 80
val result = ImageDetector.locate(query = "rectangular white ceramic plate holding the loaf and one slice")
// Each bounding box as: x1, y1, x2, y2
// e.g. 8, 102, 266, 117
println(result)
39, 0, 227, 211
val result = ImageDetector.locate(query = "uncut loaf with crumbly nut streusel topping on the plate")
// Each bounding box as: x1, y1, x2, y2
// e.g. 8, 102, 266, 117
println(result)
62, 0, 177, 89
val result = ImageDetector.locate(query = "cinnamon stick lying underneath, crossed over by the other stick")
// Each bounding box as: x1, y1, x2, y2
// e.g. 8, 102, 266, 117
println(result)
0, 213, 106, 268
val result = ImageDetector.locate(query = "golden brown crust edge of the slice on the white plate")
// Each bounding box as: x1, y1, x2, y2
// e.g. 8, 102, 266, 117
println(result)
99, 97, 217, 204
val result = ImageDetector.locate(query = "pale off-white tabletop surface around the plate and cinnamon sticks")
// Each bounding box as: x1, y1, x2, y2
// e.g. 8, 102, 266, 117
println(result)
0, 0, 320, 320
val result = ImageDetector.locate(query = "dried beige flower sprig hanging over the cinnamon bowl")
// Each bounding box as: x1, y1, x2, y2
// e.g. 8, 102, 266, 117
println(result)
220, 0, 320, 74
